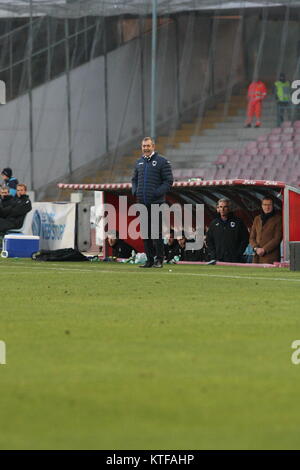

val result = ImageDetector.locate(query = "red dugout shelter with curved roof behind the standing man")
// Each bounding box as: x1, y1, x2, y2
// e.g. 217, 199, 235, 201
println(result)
58, 179, 300, 262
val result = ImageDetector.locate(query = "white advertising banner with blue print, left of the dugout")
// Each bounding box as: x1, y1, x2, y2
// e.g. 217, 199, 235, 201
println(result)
23, 202, 76, 250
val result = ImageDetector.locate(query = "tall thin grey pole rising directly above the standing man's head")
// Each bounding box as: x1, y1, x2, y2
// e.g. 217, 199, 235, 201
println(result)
150, 0, 157, 139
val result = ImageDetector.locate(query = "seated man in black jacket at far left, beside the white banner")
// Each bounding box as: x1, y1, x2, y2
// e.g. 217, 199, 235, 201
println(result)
0, 184, 31, 234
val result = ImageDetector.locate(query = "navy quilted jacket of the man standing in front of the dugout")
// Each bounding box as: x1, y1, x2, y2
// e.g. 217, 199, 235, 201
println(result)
132, 152, 173, 206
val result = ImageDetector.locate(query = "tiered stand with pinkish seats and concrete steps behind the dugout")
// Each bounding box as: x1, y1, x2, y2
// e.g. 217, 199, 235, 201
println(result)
61, 93, 288, 199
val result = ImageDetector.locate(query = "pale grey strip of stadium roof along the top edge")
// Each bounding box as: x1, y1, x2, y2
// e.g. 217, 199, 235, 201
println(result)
0, 0, 300, 18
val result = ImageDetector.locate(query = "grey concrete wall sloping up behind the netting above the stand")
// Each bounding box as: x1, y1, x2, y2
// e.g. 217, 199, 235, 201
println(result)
0, 14, 276, 195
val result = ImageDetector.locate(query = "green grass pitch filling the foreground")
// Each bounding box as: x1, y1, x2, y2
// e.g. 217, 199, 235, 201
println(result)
0, 259, 300, 449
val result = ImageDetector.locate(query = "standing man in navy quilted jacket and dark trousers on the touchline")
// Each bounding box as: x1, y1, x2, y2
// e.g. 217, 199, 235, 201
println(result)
132, 137, 173, 268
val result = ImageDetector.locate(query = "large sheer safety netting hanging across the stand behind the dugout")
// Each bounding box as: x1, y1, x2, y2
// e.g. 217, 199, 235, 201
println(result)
0, 0, 300, 197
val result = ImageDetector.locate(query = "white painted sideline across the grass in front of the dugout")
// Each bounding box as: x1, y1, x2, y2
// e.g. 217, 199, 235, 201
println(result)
0, 263, 300, 282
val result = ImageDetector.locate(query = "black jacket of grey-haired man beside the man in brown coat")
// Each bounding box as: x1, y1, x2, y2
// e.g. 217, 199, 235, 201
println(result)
206, 214, 249, 263
